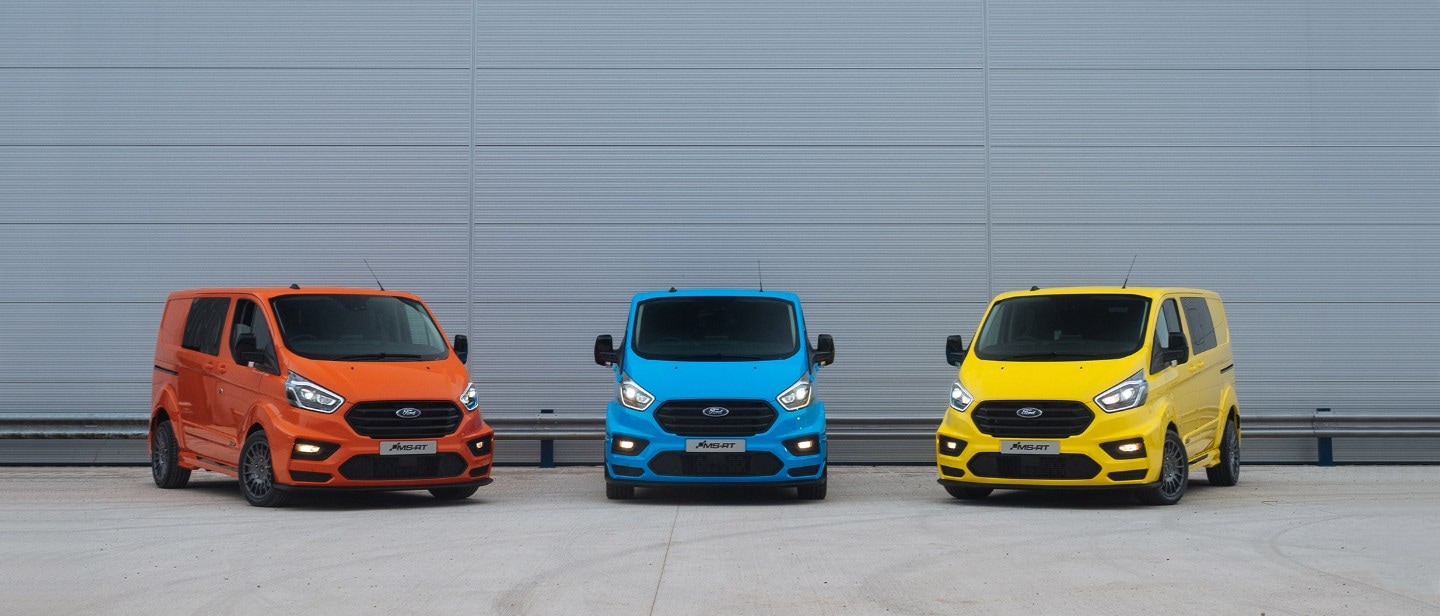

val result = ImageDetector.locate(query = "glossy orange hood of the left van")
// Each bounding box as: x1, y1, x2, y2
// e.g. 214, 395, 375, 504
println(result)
289, 358, 469, 403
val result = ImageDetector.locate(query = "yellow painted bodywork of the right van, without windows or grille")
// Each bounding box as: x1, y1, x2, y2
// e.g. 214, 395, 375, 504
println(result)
936, 286, 1238, 488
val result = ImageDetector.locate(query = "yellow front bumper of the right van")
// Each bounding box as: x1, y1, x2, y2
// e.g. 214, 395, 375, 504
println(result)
935, 407, 1168, 489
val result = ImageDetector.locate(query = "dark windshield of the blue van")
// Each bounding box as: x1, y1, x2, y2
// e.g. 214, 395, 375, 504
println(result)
631, 296, 799, 361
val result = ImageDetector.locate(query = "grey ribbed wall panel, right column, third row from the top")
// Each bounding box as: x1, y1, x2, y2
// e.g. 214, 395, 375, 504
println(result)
991, 147, 1440, 224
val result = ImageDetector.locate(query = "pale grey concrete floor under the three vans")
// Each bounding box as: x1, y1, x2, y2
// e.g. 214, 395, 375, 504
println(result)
0, 466, 1440, 616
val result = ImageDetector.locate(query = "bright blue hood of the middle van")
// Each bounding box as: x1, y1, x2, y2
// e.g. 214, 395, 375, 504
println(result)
625, 351, 808, 403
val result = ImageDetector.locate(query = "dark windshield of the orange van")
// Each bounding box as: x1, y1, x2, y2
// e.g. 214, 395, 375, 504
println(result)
271, 294, 449, 361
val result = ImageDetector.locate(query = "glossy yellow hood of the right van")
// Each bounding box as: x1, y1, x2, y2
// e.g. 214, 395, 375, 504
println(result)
960, 355, 1143, 403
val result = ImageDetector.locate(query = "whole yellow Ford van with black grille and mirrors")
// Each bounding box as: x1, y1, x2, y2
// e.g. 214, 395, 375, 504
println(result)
935, 286, 1240, 505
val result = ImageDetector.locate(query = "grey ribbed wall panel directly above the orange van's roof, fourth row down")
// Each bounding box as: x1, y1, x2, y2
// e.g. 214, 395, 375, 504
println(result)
0, 220, 468, 303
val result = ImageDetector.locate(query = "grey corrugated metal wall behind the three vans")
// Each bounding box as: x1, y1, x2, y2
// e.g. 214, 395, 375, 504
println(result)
0, 0, 1440, 461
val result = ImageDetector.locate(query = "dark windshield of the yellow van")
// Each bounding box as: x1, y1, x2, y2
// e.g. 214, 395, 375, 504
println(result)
975, 295, 1151, 361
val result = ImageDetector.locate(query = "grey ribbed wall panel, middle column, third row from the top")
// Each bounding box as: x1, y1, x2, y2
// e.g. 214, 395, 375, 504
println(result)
475, 147, 985, 225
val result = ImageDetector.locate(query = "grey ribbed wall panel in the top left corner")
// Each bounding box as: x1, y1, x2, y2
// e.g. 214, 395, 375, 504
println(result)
0, 0, 471, 69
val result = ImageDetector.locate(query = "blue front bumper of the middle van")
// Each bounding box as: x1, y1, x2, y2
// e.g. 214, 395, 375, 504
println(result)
605, 402, 827, 486
